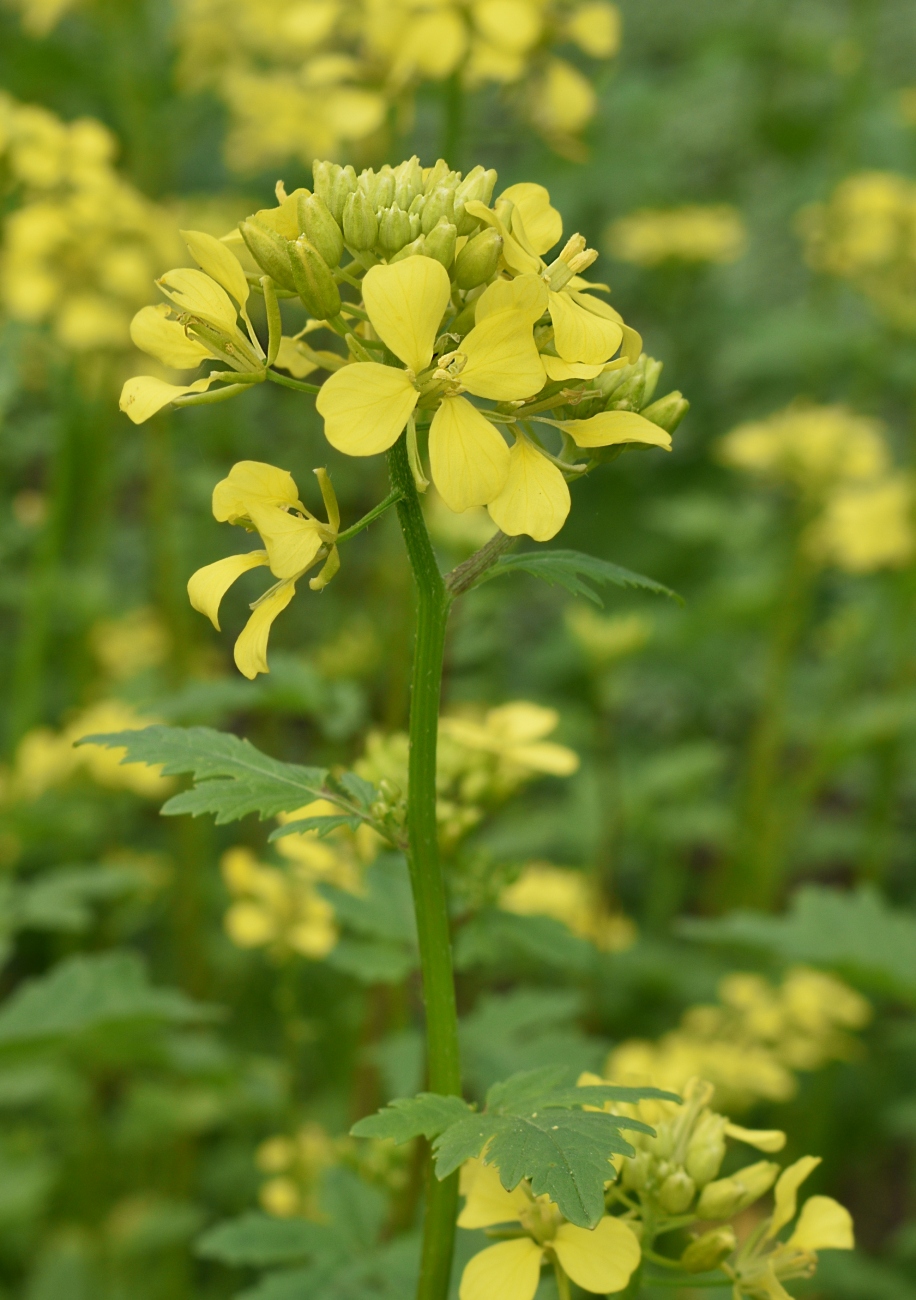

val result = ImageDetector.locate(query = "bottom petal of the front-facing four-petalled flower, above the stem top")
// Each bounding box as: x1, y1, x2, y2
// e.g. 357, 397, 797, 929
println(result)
429, 398, 509, 512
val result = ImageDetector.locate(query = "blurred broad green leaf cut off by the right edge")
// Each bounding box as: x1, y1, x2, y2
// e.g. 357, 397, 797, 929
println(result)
678, 885, 916, 1002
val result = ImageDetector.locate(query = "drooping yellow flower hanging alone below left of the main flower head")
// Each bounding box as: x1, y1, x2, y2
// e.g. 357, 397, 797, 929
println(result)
187, 460, 340, 679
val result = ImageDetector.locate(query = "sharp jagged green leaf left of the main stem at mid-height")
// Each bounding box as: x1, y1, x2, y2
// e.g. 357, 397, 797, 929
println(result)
79, 727, 327, 824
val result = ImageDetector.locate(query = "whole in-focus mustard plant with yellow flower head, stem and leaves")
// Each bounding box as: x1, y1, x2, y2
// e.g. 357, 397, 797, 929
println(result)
96, 157, 687, 1300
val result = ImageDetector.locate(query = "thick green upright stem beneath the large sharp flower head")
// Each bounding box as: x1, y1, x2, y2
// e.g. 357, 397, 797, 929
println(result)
388, 434, 461, 1300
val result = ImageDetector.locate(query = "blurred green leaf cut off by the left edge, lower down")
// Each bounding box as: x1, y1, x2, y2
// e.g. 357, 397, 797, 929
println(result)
0, 952, 218, 1045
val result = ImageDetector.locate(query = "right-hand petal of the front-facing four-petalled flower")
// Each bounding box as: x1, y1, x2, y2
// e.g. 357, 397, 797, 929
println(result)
460, 312, 547, 402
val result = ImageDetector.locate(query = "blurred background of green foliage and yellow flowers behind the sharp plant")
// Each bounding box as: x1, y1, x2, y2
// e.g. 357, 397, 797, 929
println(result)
0, 0, 916, 1300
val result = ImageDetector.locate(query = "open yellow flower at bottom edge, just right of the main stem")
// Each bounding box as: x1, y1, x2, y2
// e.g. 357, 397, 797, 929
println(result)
457, 1160, 641, 1300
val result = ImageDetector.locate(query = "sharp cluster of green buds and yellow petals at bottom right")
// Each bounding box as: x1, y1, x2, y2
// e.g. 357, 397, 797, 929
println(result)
597, 1075, 854, 1300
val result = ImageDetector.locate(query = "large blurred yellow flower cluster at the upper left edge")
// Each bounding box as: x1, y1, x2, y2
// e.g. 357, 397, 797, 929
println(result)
0, 95, 181, 354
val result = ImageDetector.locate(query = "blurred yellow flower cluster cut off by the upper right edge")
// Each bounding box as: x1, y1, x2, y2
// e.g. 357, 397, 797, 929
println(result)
798, 172, 916, 330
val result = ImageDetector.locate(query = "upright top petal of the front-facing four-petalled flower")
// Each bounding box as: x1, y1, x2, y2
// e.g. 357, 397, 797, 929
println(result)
363, 257, 451, 374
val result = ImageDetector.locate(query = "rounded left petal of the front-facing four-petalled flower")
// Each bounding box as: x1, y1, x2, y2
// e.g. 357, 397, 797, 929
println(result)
314, 361, 415, 456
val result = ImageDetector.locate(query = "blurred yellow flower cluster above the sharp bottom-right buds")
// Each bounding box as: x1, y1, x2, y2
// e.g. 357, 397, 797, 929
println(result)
605, 967, 871, 1109
